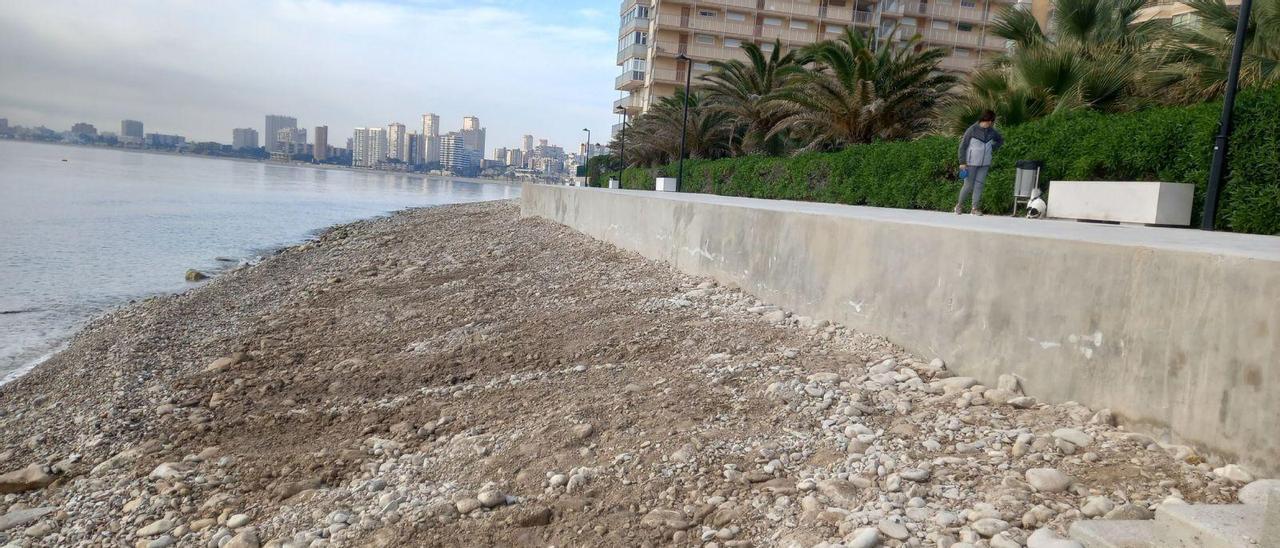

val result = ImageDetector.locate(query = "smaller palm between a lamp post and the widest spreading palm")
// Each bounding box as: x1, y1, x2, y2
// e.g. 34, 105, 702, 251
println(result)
699, 40, 805, 155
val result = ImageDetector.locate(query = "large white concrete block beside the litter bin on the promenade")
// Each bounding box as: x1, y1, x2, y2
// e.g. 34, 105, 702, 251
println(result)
1048, 181, 1196, 227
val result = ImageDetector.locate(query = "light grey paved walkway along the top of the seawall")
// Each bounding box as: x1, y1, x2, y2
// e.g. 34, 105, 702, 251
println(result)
595, 188, 1280, 262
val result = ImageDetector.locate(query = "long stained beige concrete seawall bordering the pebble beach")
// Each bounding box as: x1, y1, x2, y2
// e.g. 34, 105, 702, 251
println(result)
521, 184, 1280, 476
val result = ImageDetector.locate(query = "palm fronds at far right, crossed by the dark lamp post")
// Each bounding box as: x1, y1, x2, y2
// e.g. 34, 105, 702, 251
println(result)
1149, 0, 1280, 104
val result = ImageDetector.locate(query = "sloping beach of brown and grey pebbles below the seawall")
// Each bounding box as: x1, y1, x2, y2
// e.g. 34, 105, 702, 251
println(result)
0, 202, 1249, 548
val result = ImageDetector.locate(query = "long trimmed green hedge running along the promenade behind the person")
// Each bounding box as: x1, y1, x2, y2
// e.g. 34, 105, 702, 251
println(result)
622, 88, 1280, 234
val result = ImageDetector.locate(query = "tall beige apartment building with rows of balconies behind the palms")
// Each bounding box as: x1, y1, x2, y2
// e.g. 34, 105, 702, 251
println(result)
614, 0, 1018, 119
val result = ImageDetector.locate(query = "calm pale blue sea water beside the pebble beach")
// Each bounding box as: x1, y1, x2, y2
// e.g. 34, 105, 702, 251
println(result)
0, 141, 520, 383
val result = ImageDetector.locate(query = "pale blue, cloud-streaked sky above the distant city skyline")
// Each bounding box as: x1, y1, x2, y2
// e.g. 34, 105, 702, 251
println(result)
0, 0, 618, 151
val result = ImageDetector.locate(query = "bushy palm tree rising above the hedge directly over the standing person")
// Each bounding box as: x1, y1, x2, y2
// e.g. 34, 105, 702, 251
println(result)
946, 0, 1156, 131
